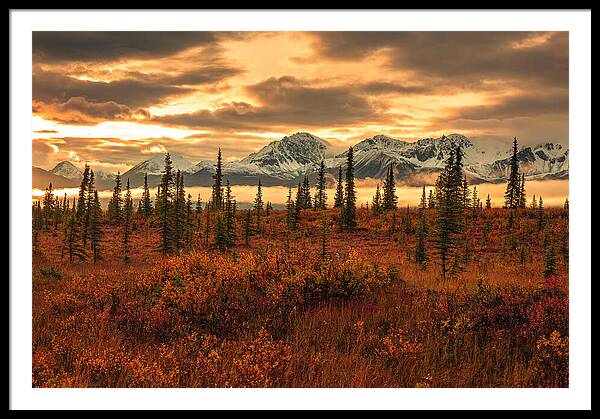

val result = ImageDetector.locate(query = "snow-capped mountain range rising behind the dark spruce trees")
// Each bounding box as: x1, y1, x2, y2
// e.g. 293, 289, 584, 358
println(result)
33, 132, 569, 189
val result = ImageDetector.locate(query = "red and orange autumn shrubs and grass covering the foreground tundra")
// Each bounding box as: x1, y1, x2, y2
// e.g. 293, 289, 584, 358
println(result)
32, 210, 568, 387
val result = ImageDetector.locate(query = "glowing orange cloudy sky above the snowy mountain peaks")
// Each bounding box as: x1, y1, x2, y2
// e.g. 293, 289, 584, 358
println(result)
32, 32, 569, 172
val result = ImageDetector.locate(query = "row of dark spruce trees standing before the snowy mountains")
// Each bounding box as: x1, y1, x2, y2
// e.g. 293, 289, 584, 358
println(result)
33, 138, 568, 278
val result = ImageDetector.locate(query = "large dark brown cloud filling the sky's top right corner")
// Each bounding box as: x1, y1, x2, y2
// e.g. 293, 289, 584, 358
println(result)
313, 32, 569, 87
